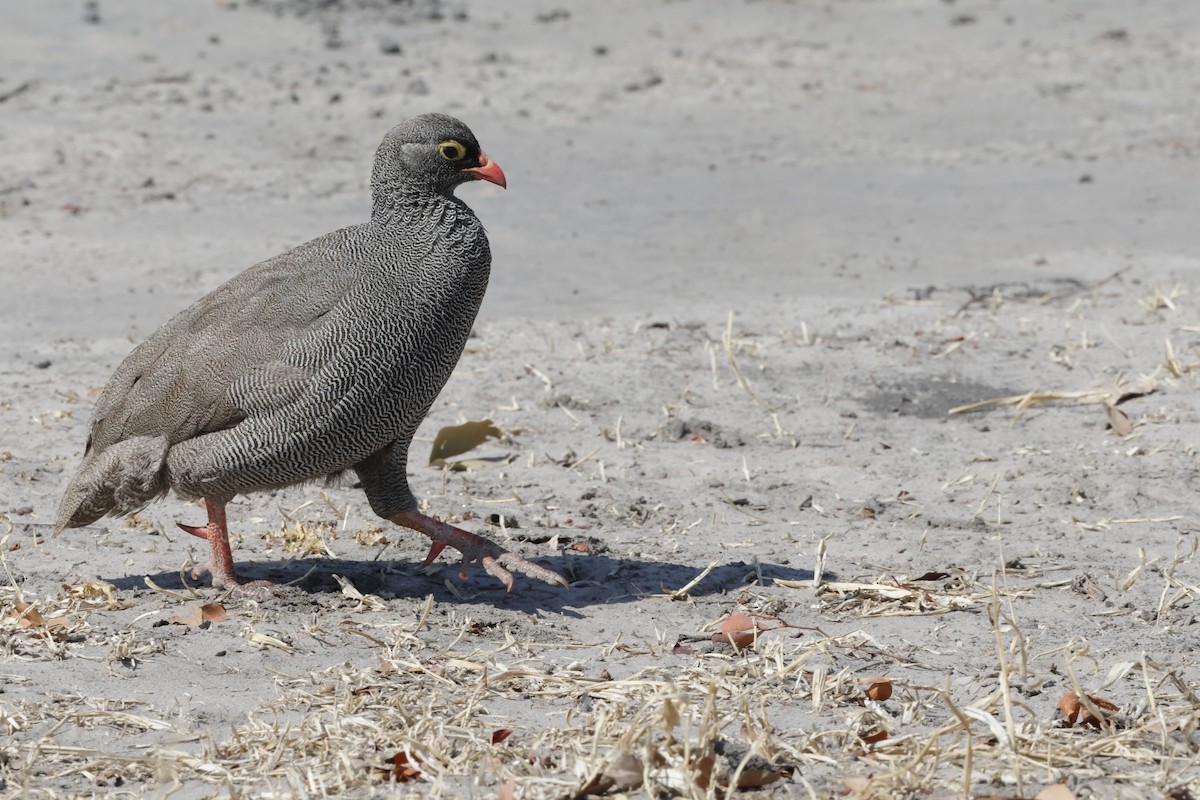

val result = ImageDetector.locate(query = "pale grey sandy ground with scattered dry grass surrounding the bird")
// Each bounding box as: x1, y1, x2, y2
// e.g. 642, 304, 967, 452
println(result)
0, 0, 1200, 798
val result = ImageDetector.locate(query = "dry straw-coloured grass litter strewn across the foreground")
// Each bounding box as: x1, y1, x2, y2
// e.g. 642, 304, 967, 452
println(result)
0, 561, 1200, 798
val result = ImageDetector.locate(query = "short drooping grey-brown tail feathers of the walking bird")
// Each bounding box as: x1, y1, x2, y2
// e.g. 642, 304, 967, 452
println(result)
54, 437, 169, 536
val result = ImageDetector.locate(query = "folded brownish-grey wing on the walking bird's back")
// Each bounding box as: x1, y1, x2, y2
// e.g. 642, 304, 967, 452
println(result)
88, 228, 356, 460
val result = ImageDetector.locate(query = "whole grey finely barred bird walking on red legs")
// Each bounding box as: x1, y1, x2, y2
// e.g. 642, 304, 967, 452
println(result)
55, 114, 571, 597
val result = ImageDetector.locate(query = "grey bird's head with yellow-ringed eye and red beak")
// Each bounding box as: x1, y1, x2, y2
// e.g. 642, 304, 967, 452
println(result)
371, 114, 506, 194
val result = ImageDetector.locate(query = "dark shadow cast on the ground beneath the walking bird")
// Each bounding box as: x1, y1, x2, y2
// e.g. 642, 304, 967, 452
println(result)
106, 554, 812, 618
